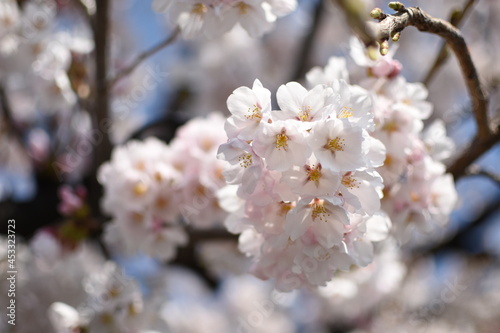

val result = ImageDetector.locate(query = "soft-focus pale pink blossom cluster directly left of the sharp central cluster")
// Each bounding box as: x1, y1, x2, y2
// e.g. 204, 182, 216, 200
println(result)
98, 113, 226, 260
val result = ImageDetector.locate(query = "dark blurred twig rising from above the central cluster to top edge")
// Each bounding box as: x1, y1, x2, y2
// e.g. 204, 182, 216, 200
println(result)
290, 1, 325, 81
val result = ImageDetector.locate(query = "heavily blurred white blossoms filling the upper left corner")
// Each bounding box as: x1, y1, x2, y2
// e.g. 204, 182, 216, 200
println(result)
0, 0, 93, 116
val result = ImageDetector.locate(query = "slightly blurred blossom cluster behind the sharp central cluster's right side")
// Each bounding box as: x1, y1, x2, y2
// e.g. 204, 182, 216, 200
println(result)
307, 40, 457, 242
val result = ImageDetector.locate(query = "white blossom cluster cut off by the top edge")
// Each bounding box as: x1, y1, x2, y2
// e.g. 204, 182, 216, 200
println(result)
153, 0, 297, 38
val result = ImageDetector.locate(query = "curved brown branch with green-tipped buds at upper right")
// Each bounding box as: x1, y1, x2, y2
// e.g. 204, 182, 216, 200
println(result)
332, 0, 500, 179
